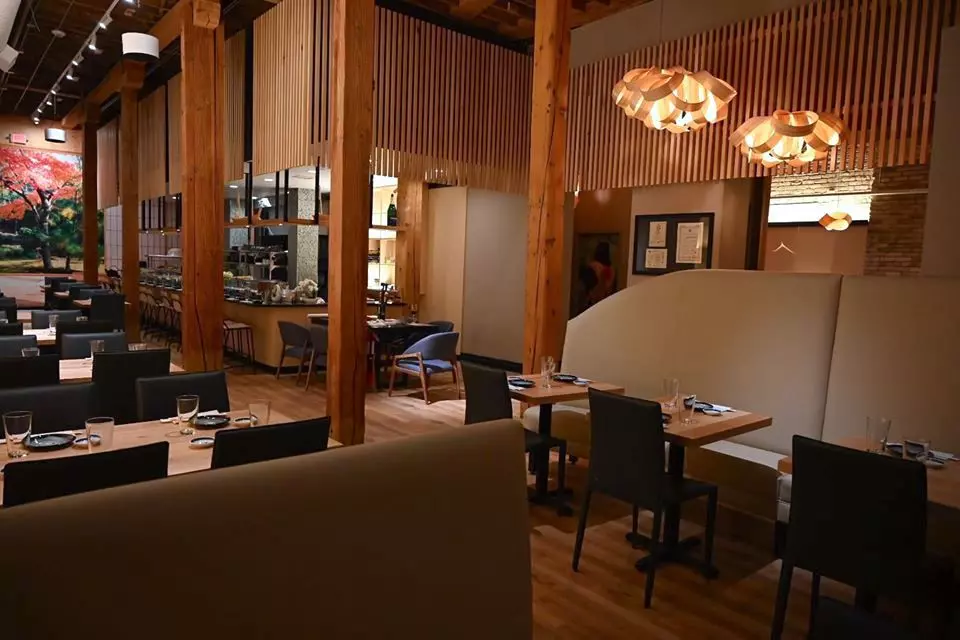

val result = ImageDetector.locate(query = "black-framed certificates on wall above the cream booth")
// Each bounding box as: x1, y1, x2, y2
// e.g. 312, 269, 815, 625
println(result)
633, 213, 714, 276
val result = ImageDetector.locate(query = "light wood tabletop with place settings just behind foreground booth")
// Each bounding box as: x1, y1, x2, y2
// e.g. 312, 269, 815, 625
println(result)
0, 411, 341, 508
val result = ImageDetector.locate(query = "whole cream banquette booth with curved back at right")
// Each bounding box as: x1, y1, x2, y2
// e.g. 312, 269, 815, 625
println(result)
524, 270, 960, 540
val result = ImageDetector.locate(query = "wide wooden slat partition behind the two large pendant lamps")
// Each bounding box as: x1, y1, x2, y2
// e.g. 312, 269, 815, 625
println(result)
568, 0, 957, 191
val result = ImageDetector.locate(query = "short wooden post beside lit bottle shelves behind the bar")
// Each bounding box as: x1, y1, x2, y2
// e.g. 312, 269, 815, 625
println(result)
397, 176, 429, 311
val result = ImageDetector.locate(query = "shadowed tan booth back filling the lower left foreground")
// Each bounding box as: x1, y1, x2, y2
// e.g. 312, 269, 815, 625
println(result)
0, 421, 532, 640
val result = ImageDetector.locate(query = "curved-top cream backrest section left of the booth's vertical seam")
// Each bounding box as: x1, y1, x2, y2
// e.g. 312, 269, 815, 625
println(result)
562, 270, 840, 453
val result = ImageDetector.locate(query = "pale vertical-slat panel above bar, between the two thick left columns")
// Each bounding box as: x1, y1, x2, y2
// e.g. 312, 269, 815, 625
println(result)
253, 0, 315, 174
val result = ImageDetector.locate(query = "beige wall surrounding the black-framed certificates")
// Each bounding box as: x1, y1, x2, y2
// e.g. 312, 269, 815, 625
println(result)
627, 179, 750, 286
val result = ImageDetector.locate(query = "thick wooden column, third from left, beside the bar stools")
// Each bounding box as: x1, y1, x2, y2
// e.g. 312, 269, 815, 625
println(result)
179, 0, 224, 371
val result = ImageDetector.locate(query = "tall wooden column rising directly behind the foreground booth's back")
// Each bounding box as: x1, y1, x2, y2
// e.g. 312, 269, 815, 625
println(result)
327, 0, 374, 444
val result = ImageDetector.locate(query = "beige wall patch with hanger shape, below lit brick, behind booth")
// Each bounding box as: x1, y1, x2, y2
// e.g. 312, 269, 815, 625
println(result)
763, 224, 867, 276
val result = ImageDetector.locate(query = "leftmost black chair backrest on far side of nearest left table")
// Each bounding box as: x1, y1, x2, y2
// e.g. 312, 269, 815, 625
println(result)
0, 383, 96, 433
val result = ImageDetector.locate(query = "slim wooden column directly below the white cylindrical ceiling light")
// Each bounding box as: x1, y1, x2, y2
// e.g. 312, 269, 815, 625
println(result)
120, 60, 144, 342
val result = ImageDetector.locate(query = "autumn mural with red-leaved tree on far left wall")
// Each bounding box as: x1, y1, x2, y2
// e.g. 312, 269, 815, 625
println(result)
0, 146, 90, 273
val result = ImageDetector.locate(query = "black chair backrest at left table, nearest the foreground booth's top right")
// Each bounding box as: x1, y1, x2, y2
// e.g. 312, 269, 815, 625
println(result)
210, 417, 330, 469
